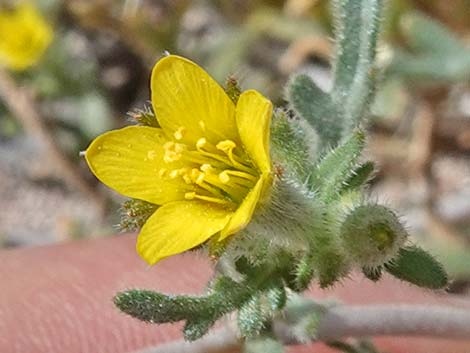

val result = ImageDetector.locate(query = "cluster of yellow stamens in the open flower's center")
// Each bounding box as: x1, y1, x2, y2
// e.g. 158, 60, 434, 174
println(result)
158, 127, 259, 206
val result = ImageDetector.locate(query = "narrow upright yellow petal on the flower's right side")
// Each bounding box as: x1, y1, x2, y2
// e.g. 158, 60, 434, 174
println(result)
236, 90, 273, 173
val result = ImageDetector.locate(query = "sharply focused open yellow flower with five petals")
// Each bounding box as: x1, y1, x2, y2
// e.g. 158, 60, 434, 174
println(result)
85, 55, 272, 264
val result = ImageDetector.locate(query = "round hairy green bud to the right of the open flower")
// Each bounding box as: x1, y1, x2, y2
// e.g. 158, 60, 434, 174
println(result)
341, 205, 408, 268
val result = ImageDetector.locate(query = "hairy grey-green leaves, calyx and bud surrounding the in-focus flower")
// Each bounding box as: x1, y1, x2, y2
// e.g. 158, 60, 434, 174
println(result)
115, 0, 447, 344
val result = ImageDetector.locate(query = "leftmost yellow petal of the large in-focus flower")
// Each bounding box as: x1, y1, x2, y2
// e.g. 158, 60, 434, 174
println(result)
85, 126, 192, 204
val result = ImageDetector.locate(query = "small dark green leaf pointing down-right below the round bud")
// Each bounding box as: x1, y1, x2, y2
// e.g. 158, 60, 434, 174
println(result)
385, 245, 448, 289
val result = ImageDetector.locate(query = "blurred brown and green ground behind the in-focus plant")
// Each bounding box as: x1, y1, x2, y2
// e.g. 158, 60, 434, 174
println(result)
0, 0, 470, 294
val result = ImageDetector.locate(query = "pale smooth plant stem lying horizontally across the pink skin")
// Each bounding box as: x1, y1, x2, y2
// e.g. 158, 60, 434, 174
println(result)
134, 304, 470, 353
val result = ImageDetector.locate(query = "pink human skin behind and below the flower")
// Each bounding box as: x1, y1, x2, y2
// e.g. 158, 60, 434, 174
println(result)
0, 235, 470, 353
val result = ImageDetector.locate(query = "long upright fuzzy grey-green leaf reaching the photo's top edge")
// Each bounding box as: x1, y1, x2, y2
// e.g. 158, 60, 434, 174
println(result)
332, 0, 383, 130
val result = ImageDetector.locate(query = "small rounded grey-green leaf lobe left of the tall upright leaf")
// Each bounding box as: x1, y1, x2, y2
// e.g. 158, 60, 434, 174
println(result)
287, 75, 344, 149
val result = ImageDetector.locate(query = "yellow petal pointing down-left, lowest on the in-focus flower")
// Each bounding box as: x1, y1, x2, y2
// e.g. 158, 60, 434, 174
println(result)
137, 201, 231, 265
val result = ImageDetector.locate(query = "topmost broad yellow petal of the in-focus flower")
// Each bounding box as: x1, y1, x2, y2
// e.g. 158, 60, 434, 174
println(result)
150, 55, 240, 144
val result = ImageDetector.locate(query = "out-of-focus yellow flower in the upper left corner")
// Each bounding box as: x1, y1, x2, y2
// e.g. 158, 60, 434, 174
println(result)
0, 2, 53, 71
